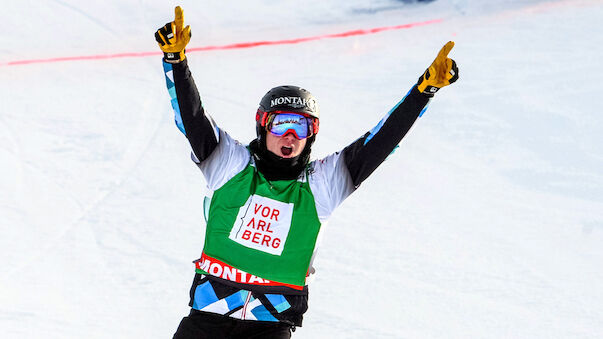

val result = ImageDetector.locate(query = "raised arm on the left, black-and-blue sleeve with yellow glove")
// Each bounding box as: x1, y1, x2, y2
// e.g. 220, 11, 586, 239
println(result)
155, 6, 220, 162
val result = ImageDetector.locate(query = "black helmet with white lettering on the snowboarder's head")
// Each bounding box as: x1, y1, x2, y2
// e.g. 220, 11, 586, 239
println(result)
255, 86, 320, 138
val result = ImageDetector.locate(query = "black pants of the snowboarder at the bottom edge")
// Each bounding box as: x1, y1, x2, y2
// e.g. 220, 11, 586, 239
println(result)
173, 310, 291, 339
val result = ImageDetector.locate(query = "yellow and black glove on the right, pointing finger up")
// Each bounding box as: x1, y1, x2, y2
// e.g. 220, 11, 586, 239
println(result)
417, 41, 459, 96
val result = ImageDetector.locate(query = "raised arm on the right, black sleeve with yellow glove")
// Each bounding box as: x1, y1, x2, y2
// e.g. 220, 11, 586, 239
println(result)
343, 41, 458, 187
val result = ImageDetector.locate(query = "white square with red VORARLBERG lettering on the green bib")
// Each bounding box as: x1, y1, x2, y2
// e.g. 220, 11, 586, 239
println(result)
229, 195, 293, 255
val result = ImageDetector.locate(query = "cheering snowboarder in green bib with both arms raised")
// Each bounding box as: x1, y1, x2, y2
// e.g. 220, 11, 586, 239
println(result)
155, 7, 458, 339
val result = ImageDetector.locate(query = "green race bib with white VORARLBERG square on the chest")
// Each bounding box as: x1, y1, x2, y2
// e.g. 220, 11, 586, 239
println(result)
198, 164, 321, 286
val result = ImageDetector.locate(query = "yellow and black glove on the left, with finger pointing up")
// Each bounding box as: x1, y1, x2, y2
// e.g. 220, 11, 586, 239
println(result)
155, 6, 191, 62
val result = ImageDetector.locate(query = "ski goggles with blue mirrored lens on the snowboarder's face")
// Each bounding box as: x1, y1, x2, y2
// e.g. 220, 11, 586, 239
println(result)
260, 112, 318, 140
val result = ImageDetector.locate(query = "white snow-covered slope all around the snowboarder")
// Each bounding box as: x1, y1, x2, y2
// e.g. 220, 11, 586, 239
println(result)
0, 0, 603, 339
